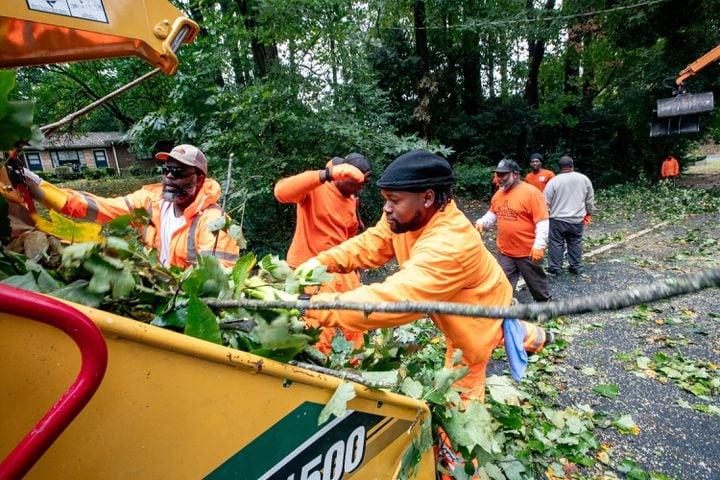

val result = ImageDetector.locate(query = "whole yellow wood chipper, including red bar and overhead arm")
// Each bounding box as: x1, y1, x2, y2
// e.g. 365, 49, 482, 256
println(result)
0, 0, 435, 480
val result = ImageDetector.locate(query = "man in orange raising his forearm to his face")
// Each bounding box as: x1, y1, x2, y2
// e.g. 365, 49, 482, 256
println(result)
275, 153, 372, 353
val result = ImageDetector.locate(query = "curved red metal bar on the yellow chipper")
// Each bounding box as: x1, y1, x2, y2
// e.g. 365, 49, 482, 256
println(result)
0, 285, 107, 480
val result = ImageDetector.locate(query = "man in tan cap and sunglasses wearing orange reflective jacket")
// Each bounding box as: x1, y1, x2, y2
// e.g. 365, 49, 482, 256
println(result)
24, 145, 239, 268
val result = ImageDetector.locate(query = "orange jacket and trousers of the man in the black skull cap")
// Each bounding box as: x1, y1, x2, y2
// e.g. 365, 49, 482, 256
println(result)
307, 202, 544, 399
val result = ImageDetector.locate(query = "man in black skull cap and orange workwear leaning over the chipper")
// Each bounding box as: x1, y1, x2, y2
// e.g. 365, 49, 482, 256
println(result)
298, 151, 552, 401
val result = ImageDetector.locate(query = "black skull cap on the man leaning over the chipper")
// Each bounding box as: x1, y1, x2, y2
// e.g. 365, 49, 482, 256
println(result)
375, 150, 454, 192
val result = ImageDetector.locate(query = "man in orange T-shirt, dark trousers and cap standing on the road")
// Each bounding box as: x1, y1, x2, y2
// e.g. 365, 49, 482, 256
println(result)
476, 159, 551, 302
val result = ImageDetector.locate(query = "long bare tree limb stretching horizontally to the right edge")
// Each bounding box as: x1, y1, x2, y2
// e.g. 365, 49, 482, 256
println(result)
205, 268, 720, 321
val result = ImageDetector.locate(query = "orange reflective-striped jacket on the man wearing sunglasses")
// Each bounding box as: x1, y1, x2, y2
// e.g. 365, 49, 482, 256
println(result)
62, 178, 240, 268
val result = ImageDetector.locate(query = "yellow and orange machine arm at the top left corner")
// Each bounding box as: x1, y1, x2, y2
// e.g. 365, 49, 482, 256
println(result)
0, 0, 199, 74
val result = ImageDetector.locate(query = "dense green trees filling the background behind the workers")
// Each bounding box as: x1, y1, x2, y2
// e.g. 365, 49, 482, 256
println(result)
9, 0, 720, 251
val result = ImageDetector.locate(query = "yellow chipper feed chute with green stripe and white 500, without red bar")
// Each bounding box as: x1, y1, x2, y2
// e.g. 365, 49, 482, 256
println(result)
0, 286, 435, 480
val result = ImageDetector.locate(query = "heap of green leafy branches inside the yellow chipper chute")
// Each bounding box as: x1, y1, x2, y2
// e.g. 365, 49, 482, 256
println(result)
0, 214, 328, 361
